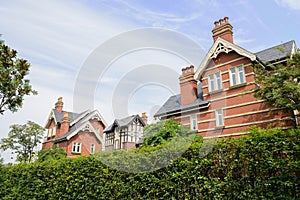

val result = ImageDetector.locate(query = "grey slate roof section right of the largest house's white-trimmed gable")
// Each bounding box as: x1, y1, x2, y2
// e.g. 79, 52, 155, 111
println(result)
254, 40, 295, 62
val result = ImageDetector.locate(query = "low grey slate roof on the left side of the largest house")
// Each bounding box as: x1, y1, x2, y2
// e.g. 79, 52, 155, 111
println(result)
154, 94, 209, 117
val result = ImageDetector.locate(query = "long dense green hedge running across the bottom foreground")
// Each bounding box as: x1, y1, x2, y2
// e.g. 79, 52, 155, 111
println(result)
0, 129, 300, 199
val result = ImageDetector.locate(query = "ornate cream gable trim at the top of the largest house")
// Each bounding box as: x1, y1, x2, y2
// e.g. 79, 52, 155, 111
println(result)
194, 37, 256, 80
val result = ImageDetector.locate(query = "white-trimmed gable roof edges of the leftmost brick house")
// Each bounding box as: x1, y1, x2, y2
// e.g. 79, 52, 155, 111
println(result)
54, 110, 107, 143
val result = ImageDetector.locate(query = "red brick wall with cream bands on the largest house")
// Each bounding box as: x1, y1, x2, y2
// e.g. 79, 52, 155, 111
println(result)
173, 52, 294, 137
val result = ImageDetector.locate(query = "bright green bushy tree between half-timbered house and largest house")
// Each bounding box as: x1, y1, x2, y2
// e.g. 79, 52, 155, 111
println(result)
141, 118, 195, 147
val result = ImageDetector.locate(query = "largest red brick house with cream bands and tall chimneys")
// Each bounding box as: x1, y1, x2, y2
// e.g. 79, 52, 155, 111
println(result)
154, 17, 297, 138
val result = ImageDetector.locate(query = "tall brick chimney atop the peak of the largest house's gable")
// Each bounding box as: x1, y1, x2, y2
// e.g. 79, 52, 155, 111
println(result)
212, 17, 233, 43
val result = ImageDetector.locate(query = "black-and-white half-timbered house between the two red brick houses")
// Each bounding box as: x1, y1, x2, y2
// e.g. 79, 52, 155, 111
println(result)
104, 113, 147, 151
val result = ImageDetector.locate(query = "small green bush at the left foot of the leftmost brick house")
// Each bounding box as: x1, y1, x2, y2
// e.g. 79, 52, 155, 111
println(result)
38, 145, 67, 162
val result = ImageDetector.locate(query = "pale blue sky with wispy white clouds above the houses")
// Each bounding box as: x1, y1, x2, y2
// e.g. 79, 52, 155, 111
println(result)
0, 0, 300, 162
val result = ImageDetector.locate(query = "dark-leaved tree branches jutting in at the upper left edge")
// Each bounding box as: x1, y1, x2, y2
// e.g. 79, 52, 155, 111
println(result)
0, 38, 37, 114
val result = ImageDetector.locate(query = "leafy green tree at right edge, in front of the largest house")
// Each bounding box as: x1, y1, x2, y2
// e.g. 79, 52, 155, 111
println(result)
254, 50, 300, 112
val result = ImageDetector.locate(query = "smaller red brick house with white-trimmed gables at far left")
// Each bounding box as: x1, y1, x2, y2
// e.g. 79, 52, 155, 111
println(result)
42, 97, 107, 157
